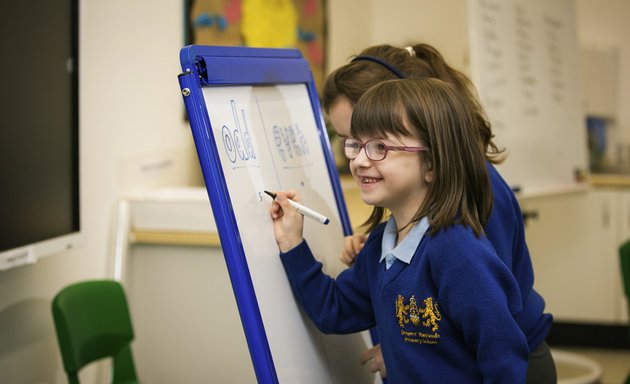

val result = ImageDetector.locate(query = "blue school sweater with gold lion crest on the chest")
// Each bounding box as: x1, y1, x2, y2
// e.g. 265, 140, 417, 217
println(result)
281, 224, 529, 383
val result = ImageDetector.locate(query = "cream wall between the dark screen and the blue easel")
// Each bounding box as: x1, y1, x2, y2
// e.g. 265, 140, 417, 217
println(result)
0, 0, 198, 383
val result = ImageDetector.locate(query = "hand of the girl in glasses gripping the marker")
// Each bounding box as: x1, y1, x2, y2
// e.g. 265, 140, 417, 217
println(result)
269, 190, 304, 253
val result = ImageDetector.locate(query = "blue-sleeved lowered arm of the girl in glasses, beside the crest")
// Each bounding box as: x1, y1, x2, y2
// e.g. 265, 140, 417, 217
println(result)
430, 230, 529, 383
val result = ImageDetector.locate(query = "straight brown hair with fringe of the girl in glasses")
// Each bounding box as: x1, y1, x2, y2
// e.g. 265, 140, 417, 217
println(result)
351, 78, 492, 235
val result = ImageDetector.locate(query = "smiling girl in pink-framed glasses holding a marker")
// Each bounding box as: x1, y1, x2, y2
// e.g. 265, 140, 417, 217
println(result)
271, 79, 529, 383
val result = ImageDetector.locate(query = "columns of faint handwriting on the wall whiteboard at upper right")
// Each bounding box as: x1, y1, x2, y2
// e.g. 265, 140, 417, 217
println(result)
477, 0, 572, 130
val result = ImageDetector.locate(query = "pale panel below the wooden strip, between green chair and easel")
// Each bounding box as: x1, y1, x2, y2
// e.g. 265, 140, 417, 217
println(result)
127, 244, 256, 384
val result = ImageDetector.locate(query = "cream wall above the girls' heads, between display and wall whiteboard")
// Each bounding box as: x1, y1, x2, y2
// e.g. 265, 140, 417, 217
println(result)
328, 0, 469, 73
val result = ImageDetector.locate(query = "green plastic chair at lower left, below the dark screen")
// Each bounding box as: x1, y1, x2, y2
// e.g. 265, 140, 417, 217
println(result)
52, 280, 138, 384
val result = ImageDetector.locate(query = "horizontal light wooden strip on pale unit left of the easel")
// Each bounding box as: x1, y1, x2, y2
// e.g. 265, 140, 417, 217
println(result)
129, 230, 221, 248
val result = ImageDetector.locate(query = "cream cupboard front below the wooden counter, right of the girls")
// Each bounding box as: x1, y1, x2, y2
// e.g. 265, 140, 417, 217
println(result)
521, 191, 621, 323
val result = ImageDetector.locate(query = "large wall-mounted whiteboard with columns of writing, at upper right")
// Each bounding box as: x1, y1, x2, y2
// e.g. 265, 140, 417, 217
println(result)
469, 0, 588, 194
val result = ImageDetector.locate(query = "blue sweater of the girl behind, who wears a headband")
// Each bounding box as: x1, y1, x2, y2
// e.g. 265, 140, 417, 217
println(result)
484, 163, 553, 352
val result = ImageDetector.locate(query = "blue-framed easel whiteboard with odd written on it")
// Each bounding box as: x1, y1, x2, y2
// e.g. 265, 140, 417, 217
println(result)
180, 47, 375, 384
